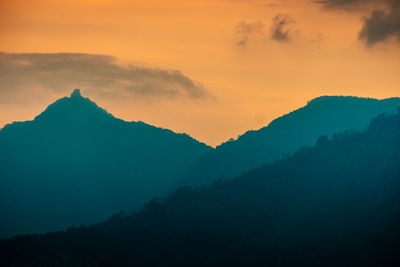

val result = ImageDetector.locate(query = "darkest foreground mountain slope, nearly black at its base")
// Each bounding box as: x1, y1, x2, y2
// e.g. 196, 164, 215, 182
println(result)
0, 109, 400, 267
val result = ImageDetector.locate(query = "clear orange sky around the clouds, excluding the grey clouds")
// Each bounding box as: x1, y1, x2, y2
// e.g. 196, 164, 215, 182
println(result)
0, 0, 400, 145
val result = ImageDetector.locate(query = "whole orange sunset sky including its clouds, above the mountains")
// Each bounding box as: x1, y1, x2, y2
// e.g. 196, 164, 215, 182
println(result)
0, 0, 400, 146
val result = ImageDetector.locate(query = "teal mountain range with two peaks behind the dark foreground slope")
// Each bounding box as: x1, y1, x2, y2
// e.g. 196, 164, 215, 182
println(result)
0, 89, 400, 238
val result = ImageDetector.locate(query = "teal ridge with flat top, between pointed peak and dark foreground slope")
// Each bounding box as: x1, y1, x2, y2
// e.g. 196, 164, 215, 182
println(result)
178, 96, 400, 186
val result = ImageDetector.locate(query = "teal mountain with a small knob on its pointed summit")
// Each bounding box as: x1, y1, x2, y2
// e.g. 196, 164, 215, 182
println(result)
0, 89, 211, 238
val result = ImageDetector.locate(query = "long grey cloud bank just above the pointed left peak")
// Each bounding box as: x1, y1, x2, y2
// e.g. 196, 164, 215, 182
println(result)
0, 52, 208, 102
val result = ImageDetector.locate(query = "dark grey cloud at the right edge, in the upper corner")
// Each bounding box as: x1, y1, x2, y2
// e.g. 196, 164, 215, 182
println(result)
359, 0, 400, 46
